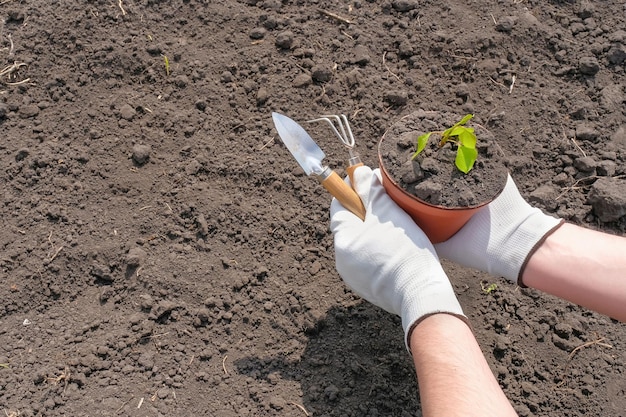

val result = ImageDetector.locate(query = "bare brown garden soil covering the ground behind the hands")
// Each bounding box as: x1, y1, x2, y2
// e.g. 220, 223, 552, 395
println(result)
0, 0, 626, 417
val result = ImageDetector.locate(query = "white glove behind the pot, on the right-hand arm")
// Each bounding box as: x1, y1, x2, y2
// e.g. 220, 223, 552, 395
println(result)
435, 175, 563, 286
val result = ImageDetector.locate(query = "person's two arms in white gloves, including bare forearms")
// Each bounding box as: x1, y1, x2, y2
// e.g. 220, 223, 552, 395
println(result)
270, 111, 626, 416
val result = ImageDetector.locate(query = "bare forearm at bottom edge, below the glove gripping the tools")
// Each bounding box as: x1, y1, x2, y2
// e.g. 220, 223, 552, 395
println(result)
411, 314, 517, 417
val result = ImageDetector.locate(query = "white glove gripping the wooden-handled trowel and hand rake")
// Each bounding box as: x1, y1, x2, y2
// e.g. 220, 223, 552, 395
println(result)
330, 166, 465, 349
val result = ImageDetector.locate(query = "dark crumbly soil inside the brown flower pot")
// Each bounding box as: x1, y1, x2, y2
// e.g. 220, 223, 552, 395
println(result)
378, 111, 508, 208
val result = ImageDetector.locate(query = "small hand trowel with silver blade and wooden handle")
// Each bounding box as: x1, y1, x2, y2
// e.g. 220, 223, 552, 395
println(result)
272, 112, 365, 220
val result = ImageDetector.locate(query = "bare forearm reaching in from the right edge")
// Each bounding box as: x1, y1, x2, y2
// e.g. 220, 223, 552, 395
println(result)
522, 224, 626, 321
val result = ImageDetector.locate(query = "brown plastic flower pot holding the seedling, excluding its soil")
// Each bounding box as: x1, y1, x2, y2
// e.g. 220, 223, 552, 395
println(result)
378, 112, 506, 243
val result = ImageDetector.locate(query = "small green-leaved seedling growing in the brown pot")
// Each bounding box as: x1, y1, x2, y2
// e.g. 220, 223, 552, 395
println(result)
411, 114, 478, 174
